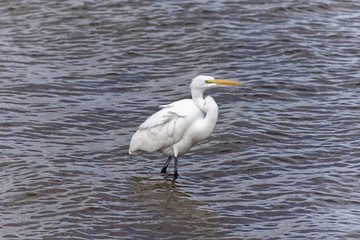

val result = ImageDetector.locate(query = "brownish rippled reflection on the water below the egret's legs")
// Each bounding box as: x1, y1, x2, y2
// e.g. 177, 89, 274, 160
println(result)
128, 177, 221, 238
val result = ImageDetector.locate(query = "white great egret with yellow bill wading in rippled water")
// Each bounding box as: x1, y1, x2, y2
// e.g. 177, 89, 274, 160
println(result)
129, 76, 242, 178
